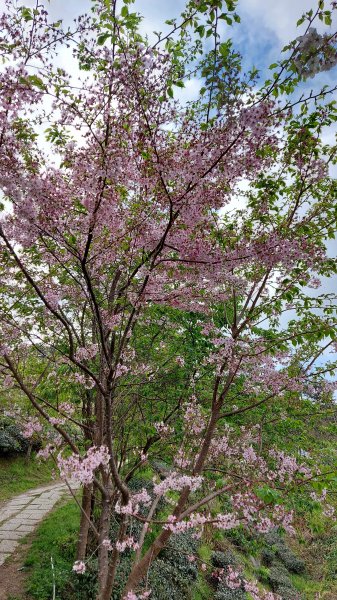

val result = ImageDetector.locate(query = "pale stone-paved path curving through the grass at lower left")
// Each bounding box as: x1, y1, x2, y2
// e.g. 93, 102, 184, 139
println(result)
0, 483, 75, 566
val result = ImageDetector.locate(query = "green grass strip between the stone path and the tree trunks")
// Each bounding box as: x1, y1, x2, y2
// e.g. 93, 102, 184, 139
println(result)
25, 501, 80, 600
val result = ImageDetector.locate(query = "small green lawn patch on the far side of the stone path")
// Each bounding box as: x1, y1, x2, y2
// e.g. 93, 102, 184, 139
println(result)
0, 456, 52, 502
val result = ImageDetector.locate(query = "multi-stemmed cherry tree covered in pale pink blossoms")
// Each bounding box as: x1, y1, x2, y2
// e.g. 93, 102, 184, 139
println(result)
0, 0, 337, 600
